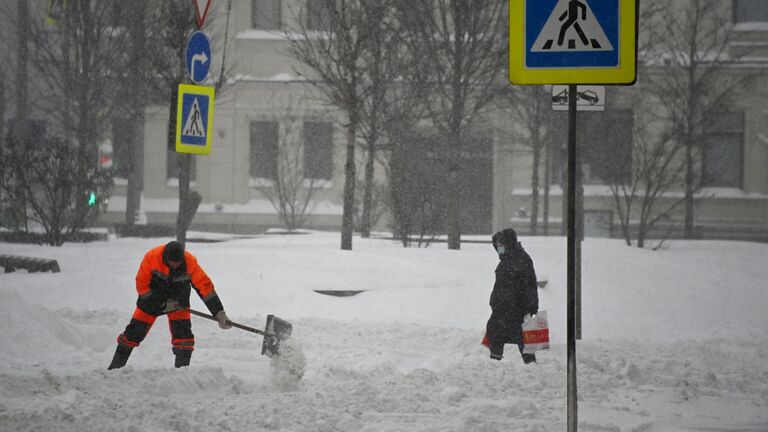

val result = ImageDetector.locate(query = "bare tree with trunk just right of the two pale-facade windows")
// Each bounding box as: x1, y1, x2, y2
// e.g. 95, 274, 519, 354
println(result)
288, 0, 372, 250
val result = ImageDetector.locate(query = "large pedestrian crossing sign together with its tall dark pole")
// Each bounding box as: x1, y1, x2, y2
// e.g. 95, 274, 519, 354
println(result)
509, 0, 638, 432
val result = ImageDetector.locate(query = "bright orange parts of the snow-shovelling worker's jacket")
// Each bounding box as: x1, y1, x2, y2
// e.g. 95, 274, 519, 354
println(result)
136, 245, 216, 301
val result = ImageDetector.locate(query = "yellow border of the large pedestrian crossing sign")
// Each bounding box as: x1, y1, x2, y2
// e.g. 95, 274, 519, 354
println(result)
509, 0, 637, 85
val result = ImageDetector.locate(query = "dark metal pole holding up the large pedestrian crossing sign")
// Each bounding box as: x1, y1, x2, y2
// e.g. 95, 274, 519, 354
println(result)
566, 84, 579, 432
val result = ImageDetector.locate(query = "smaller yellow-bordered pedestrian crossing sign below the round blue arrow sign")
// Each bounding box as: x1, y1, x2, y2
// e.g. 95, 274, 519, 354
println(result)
176, 84, 214, 155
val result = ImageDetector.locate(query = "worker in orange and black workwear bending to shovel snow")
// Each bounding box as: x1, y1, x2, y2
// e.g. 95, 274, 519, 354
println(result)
108, 241, 232, 369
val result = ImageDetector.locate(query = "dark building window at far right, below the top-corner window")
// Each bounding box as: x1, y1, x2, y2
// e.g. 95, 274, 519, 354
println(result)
702, 112, 744, 188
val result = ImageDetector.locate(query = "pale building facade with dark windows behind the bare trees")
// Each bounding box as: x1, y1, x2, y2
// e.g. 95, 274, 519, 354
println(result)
4, 0, 768, 240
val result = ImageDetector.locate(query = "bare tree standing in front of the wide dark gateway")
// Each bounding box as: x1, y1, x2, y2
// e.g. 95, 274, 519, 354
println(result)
399, 0, 507, 249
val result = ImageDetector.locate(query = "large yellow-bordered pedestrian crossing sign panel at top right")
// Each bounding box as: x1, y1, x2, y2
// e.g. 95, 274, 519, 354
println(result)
509, 0, 638, 84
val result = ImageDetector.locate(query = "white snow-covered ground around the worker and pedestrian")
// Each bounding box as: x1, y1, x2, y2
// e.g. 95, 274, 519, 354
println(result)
0, 233, 768, 432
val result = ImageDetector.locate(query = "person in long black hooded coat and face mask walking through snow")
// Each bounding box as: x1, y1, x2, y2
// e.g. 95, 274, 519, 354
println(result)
485, 228, 539, 363
